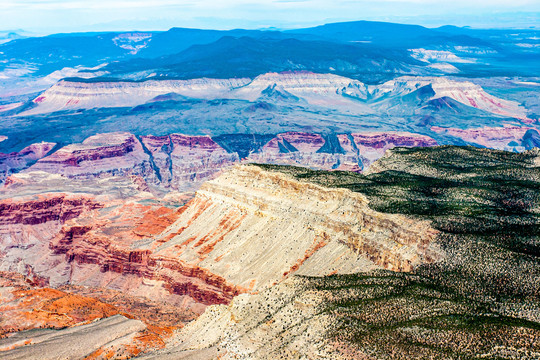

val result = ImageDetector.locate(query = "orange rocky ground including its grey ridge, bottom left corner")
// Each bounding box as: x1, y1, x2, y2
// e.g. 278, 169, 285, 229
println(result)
0, 272, 190, 359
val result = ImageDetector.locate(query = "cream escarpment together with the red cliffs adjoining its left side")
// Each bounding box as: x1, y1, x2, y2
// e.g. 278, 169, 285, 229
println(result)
2, 161, 443, 309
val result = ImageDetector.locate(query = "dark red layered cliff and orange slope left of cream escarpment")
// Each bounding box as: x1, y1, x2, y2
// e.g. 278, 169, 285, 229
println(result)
44, 200, 243, 305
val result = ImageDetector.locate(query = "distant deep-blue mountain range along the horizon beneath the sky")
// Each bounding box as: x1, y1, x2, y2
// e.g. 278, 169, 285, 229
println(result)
0, 21, 540, 82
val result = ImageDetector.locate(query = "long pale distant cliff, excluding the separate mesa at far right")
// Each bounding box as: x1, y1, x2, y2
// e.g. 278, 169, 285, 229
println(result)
25, 72, 368, 115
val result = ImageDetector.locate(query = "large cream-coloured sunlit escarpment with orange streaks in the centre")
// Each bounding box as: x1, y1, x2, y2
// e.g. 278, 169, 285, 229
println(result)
155, 166, 442, 289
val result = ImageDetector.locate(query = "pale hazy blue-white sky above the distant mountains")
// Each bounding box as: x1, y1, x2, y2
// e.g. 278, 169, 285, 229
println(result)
0, 0, 540, 33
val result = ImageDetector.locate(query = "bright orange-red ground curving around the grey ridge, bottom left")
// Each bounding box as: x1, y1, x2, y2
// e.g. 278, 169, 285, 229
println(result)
0, 272, 190, 359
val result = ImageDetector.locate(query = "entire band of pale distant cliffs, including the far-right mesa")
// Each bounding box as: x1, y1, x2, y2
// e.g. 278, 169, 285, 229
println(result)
23, 72, 531, 122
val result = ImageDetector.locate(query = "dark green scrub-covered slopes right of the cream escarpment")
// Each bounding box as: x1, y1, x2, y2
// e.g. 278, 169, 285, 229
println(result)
253, 147, 540, 359
